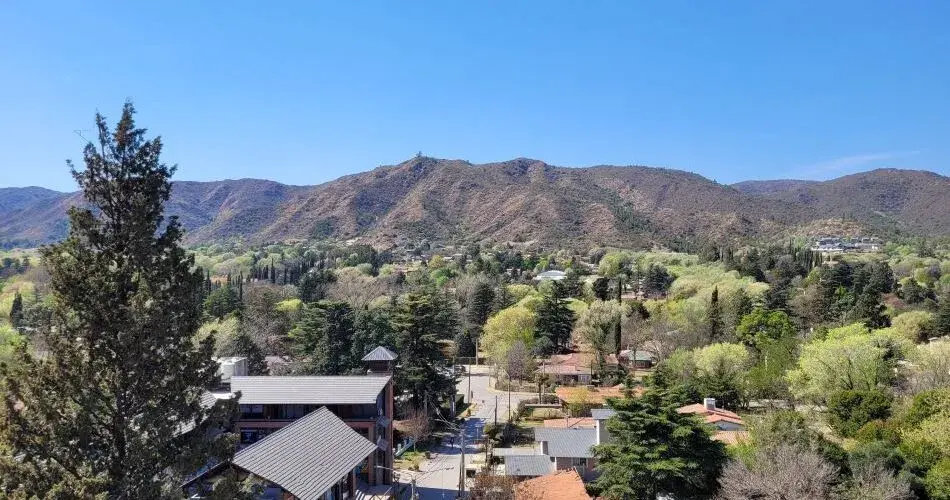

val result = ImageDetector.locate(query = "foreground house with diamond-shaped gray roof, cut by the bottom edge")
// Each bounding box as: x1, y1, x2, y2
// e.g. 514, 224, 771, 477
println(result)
183, 407, 377, 500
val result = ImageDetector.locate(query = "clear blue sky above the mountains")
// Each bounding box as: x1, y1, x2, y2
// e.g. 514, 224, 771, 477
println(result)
0, 0, 950, 189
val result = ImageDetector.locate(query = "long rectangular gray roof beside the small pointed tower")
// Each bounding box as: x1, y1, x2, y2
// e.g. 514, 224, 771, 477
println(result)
231, 375, 389, 405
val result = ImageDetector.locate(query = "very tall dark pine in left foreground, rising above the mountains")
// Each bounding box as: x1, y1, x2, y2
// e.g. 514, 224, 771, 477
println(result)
0, 103, 234, 499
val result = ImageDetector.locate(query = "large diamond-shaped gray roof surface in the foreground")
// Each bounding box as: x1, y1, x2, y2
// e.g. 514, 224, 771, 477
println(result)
232, 408, 376, 500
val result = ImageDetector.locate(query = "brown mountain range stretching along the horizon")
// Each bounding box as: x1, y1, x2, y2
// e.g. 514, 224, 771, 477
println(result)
0, 157, 950, 248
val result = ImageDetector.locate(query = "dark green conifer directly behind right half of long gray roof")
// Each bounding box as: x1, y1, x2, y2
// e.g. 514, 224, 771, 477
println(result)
290, 300, 356, 375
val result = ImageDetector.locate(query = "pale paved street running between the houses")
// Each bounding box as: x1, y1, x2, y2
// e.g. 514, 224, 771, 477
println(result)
410, 366, 531, 500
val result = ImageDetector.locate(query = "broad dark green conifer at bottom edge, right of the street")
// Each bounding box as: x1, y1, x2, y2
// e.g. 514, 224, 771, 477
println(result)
593, 389, 728, 500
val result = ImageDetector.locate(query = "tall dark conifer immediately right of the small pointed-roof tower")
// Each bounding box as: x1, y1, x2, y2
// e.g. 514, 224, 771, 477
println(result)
393, 291, 455, 412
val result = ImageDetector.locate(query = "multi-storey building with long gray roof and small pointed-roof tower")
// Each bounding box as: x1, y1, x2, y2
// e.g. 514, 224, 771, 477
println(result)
230, 347, 396, 485
